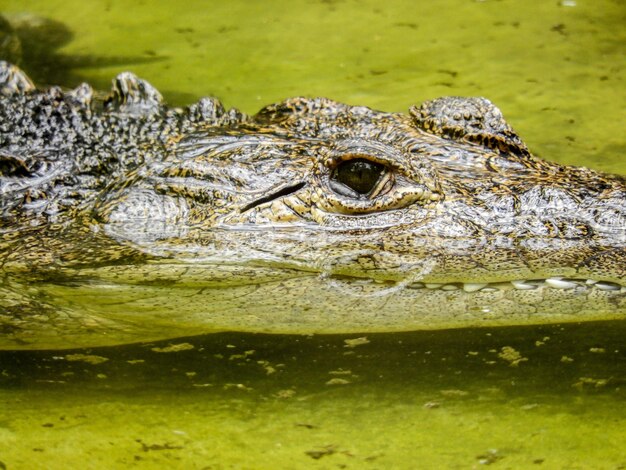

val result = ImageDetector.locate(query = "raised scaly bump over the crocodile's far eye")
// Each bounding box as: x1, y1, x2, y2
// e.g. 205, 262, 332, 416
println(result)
409, 96, 530, 156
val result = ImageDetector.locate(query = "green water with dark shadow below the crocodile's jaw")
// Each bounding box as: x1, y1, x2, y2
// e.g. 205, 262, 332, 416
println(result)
0, 322, 626, 469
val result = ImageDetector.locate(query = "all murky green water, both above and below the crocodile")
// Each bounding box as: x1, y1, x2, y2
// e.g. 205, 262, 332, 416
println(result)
0, 0, 626, 469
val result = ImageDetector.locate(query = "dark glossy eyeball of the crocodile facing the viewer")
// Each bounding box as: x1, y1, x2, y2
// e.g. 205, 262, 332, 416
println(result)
330, 158, 386, 196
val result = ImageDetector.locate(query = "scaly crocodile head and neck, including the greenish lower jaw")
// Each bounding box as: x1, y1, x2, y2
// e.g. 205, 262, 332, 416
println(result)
0, 63, 626, 349
